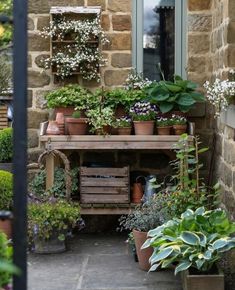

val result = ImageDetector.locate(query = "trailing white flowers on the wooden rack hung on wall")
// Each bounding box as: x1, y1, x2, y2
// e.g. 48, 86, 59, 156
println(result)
40, 17, 109, 81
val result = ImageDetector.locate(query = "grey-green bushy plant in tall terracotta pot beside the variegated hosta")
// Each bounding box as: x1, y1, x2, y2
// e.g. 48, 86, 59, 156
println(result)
119, 194, 168, 271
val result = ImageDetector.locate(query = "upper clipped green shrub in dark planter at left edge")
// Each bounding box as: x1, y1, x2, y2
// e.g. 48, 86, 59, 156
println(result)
0, 128, 13, 172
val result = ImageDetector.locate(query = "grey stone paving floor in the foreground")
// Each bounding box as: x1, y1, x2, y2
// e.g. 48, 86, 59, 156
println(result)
28, 234, 181, 290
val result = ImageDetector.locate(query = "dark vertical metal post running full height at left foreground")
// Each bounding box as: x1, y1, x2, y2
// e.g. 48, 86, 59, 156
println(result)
13, 0, 27, 290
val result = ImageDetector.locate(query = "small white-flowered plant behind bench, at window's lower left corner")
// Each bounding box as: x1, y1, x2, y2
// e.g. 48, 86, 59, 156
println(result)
124, 69, 152, 90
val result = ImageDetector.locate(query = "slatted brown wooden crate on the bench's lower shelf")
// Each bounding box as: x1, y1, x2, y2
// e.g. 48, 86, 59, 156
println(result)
80, 167, 130, 203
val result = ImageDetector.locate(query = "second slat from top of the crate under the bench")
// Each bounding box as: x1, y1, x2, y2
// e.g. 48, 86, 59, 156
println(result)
80, 176, 129, 187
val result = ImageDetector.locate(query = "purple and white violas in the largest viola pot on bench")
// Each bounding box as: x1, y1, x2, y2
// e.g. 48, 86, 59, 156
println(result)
130, 102, 157, 121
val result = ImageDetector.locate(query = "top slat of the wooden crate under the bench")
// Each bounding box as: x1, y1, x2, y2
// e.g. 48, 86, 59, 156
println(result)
80, 167, 128, 176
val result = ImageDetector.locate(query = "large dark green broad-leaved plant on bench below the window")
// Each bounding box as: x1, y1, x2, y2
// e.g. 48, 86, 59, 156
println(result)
146, 76, 205, 113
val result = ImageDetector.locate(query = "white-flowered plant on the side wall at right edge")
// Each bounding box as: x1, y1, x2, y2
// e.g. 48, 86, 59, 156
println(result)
204, 76, 235, 118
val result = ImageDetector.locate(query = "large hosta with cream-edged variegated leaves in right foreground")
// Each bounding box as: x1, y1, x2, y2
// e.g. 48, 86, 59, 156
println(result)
142, 207, 235, 274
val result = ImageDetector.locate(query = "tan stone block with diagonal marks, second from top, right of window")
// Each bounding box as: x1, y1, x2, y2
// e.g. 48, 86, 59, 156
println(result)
188, 14, 212, 32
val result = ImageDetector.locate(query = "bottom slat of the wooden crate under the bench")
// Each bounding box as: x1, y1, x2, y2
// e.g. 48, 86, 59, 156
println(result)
81, 194, 129, 203
